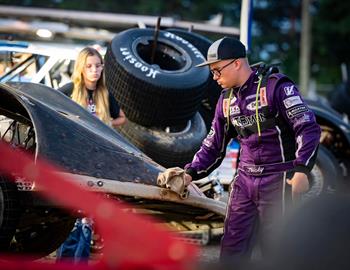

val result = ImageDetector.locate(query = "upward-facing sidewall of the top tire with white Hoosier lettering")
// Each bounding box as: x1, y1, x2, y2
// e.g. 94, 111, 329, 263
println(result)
111, 28, 209, 89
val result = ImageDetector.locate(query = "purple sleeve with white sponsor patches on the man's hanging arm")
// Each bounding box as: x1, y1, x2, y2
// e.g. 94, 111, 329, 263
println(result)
275, 82, 321, 173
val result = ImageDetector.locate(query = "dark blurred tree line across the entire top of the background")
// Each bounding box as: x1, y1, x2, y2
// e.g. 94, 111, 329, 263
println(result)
1, 0, 350, 89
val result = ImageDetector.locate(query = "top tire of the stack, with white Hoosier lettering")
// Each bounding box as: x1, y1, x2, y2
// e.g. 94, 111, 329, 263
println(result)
105, 28, 209, 126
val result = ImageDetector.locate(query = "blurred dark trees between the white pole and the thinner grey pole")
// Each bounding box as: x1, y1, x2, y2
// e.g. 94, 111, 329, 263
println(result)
251, 0, 301, 81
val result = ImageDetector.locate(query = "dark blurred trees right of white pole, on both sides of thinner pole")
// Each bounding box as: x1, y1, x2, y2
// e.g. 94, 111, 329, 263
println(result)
252, 0, 350, 87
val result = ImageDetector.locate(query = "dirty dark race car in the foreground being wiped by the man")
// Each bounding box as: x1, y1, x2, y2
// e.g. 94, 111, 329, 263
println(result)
0, 82, 225, 257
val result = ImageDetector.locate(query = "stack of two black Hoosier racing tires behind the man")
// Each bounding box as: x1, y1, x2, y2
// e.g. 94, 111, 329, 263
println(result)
105, 28, 213, 167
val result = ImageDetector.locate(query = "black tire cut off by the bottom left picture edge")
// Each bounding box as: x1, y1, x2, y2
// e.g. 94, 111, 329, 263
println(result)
0, 175, 20, 252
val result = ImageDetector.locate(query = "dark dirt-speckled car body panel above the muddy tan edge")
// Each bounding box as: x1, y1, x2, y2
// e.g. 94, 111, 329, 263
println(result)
0, 83, 161, 184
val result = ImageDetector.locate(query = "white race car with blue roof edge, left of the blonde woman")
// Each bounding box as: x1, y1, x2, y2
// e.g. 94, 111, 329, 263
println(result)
0, 41, 82, 88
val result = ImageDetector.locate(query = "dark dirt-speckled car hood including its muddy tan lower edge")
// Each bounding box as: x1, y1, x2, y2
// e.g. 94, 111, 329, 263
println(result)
0, 82, 226, 216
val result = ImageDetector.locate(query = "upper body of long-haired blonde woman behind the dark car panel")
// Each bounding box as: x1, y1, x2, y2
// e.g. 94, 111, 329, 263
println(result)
59, 47, 126, 127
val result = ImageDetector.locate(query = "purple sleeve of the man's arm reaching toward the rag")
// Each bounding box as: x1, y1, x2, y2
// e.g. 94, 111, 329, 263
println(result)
185, 94, 232, 180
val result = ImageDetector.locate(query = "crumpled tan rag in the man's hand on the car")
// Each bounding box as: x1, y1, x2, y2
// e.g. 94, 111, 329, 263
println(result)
157, 167, 189, 199
